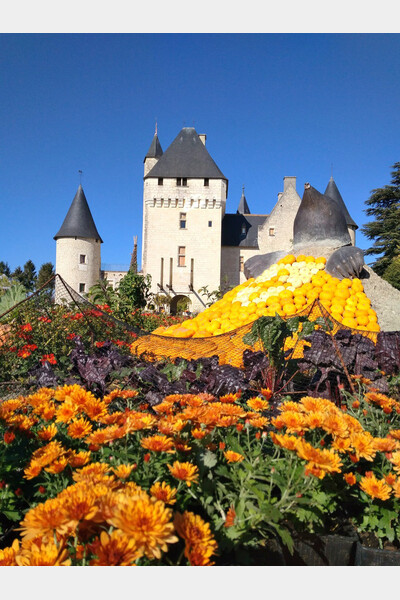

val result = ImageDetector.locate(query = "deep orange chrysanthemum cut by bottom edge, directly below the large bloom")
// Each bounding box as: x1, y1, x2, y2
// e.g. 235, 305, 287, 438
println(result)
88, 529, 143, 567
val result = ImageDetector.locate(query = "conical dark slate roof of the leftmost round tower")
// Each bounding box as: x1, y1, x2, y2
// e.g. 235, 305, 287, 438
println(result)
54, 185, 103, 243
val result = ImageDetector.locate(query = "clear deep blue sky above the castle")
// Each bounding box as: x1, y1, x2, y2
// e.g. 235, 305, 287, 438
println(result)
0, 33, 400, 269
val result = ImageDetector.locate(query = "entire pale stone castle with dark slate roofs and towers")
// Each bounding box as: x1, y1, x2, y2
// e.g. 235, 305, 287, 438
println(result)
54, 127, 357, 313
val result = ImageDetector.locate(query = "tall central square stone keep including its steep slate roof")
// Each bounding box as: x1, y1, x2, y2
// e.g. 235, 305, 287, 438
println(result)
142, 127, 228, 312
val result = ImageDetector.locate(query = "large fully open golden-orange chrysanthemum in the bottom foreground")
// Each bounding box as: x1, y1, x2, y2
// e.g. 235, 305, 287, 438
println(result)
108, 494, 178, 559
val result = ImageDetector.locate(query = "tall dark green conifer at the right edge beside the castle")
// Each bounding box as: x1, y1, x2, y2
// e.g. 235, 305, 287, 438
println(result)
361, 162, 400, 276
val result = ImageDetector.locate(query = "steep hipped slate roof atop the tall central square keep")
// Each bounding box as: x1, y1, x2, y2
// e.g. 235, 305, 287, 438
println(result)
145, 127, 226, 180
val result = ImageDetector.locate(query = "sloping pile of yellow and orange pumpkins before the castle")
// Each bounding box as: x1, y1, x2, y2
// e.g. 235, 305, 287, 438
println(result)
152, 254, 380, 338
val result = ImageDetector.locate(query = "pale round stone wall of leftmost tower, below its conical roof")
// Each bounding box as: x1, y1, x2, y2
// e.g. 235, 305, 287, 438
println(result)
56, 237, 101, 294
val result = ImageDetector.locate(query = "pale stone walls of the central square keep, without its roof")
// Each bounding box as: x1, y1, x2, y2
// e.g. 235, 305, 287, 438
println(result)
142, 178, 226, 312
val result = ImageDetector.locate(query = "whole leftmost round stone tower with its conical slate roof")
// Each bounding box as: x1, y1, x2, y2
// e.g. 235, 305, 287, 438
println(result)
54, 185, 103, 294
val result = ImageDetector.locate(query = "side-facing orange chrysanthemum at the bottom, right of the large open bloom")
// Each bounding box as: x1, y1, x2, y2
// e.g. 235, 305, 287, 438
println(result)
174, 511, 218, 566
